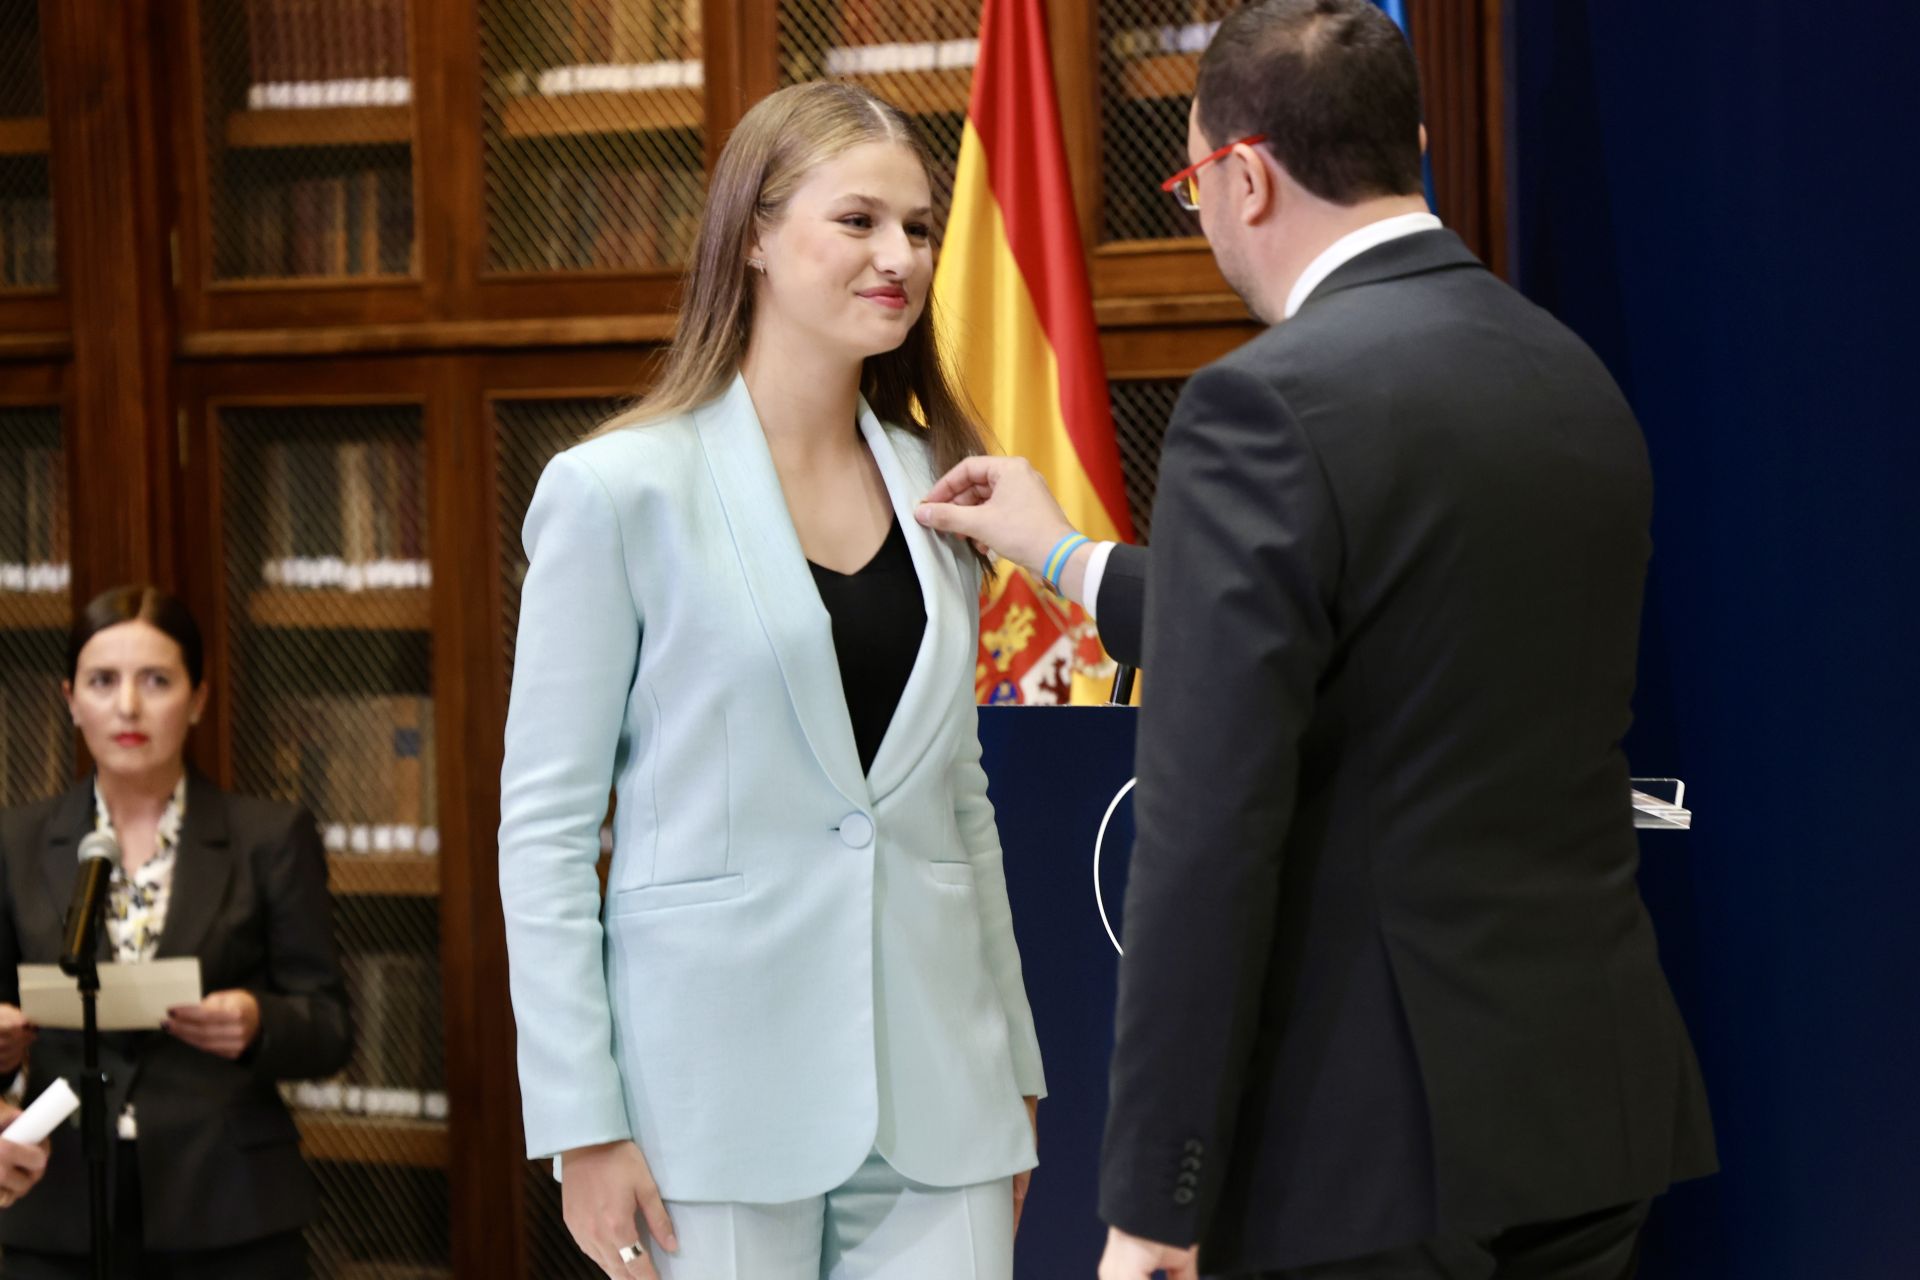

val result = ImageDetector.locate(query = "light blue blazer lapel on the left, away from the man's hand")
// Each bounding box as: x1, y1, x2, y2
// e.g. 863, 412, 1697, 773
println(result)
695, 376, 872, 808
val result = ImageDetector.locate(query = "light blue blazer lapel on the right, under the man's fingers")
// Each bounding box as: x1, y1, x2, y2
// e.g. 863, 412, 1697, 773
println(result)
860, 397, 972, 798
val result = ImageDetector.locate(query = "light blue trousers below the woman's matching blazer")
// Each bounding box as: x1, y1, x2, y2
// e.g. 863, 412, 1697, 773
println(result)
653, 1153, 1014, 1280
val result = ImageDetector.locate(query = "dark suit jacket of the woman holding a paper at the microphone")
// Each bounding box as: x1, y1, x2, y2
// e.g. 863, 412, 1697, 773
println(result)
0, 777, 353, 1253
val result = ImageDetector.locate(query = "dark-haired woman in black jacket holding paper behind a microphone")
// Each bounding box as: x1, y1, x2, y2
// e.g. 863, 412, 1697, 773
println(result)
0, 587, 351, 1280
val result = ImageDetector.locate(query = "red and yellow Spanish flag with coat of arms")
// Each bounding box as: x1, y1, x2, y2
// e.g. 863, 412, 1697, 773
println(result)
933, 0, 1133, 702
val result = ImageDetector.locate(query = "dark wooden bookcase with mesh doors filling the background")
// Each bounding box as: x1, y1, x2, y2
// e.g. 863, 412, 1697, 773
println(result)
0, 0, 1503, 1280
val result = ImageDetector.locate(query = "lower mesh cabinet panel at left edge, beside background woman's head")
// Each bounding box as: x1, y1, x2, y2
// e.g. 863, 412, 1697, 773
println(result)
0, 405, 73, 808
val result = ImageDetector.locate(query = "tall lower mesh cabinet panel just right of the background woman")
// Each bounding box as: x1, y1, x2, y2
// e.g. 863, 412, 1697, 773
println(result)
215, 405, 449, 1278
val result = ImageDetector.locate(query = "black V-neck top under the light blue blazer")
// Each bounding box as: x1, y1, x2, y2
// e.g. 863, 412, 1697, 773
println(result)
806, 520, 927, 771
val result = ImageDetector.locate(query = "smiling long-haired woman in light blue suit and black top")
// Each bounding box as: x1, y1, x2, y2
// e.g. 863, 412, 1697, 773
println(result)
499, 84, 1044, 1280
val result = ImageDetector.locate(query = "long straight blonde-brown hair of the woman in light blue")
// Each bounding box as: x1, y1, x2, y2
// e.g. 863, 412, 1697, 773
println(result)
593, 81, 987, 474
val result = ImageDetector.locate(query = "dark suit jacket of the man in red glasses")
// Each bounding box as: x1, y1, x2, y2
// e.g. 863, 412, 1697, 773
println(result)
1098, 230, 1715, 1270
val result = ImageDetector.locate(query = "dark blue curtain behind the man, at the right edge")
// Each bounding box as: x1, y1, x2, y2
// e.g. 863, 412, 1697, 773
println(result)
1507, 0, 1920, 1280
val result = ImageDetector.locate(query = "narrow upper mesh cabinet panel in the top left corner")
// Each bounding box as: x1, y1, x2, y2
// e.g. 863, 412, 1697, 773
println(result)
0, 0, 60, 294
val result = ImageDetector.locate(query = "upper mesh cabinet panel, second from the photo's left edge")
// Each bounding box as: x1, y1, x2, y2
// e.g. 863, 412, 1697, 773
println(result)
196, 0, 419, 282
